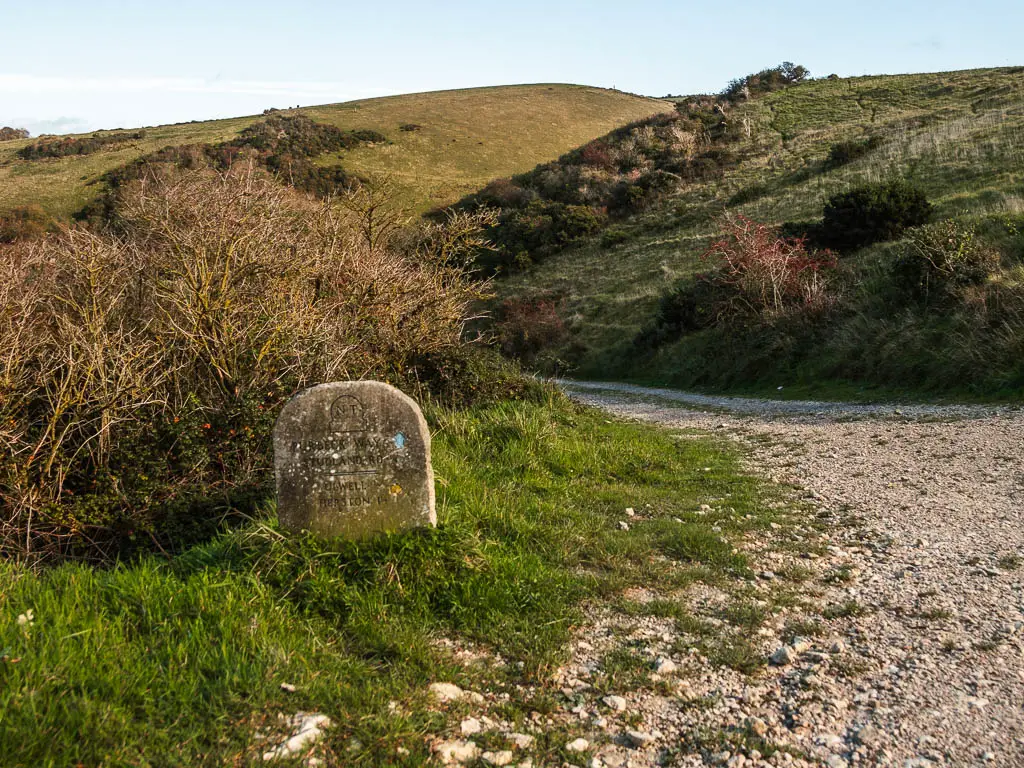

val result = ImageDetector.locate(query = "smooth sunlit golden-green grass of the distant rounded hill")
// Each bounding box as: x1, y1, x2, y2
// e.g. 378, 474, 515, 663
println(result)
0, 84, 671, 217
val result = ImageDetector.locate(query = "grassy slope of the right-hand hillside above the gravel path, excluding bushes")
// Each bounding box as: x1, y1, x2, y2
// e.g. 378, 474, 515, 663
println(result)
498, 68, 1024, 399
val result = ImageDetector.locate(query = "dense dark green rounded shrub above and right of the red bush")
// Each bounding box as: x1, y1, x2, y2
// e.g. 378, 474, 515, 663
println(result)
817, 181, 933, 252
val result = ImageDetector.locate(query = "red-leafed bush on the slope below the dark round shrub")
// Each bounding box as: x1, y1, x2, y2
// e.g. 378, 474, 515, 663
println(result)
702, 216, 836, 314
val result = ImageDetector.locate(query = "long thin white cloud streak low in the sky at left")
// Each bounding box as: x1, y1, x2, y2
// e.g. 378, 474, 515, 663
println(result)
0, 73, 382, 98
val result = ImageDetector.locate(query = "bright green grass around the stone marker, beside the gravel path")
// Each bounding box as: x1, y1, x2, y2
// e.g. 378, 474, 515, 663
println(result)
0, 399, 778, 766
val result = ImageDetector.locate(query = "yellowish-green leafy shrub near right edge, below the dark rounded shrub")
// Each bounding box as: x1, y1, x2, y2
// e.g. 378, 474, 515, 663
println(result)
892, 219, 999, 303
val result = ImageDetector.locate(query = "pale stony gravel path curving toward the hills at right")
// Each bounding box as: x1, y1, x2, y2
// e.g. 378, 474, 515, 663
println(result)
562, 382, 1024, 768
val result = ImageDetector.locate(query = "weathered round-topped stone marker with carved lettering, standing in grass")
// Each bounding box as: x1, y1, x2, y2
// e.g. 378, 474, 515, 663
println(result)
273, 381, 437, 539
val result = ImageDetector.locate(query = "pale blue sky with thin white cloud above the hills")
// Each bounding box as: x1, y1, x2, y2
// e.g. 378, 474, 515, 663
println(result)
0, 0, 1024, 134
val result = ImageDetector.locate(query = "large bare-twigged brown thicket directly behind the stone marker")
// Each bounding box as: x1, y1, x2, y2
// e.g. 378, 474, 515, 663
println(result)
0, 169, 491, 554
